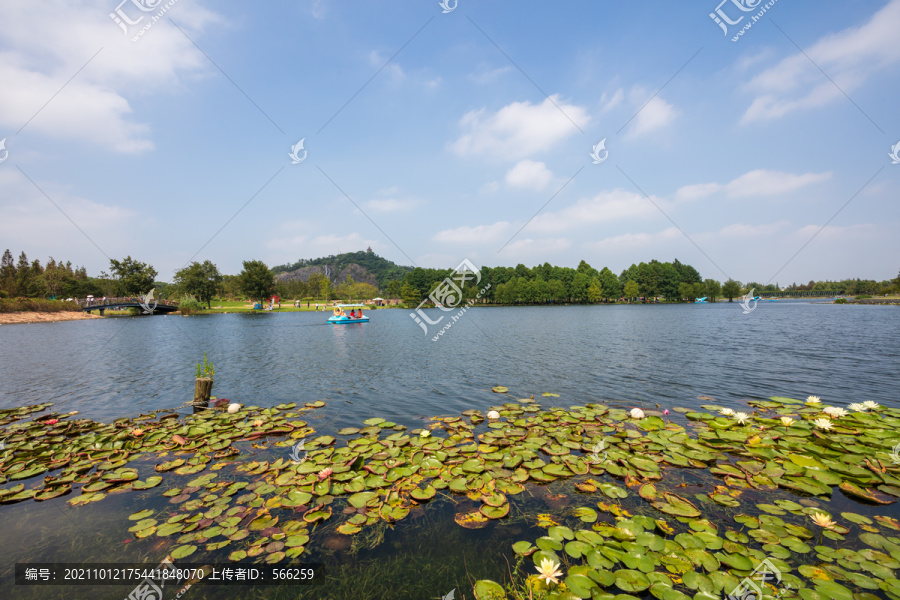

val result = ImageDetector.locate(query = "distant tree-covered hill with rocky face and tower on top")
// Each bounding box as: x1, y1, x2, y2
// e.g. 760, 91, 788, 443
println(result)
272, 250, 412, 289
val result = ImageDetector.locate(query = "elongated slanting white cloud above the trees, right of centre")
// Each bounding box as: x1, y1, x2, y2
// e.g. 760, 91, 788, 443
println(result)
526, 188, 664, 233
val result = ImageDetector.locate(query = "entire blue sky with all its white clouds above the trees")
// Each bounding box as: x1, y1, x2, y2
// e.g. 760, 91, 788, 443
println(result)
0, 0, 900, 285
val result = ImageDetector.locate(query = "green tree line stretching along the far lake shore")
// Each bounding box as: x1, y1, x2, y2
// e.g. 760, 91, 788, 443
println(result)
0, 249, 900, 307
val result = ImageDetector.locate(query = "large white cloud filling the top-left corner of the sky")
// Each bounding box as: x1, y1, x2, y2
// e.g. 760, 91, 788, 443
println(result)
0, 0, 219, 152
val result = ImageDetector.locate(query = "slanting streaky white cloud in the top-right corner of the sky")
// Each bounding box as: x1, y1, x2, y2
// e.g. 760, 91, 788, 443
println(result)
741, 0, 900, 123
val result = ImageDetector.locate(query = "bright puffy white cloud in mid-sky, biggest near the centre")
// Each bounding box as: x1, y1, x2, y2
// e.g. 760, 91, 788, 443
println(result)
449, 94, 591, 160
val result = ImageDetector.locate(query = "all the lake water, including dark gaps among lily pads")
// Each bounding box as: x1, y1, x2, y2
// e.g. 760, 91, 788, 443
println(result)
0, 301, 900, 600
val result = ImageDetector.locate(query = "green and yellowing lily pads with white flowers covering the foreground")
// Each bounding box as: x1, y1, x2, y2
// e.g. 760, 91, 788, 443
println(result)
0, 387, 900, 600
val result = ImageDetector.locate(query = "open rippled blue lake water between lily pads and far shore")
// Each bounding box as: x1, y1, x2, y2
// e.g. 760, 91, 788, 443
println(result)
0, 301, 900, 427
